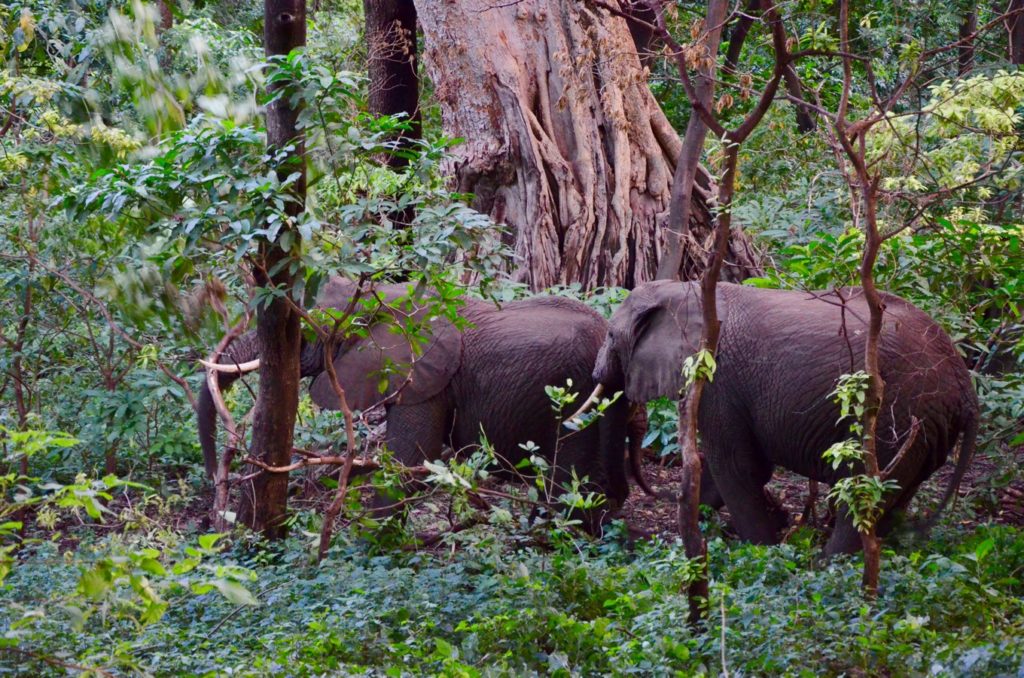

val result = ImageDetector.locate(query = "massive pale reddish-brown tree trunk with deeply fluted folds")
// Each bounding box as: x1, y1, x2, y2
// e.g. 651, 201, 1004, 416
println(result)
417, 0, 761, 290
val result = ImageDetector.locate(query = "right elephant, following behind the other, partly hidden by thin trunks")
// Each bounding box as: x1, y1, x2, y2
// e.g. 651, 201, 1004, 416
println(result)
594, 281, 978, 555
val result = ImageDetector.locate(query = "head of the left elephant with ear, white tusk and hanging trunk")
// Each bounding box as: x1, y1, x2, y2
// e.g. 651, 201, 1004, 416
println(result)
197, 279, 462, 478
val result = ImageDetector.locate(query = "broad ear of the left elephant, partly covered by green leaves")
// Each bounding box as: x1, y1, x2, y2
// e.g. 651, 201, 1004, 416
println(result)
309, 319, 462, 410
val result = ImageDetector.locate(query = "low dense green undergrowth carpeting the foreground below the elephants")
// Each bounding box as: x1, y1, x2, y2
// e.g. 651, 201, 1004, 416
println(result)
0, 518, 1024, 676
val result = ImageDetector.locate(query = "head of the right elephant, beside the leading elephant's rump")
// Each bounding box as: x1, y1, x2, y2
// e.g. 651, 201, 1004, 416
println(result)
594, 281, 702, 402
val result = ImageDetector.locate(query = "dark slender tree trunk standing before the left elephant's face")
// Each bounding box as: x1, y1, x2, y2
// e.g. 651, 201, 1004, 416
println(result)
239, 0, 306, 539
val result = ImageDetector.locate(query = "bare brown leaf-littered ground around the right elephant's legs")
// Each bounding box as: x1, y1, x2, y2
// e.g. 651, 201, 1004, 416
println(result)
623, 447, 1024, 537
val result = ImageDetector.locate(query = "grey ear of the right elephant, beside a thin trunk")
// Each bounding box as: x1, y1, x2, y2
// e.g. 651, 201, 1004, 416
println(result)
626, 283, 701, 402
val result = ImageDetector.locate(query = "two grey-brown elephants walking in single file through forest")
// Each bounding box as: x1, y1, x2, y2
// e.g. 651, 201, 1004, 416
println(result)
197, 279, 978, 554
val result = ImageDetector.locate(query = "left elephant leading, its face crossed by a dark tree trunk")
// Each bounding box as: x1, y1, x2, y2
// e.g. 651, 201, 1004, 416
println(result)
197, 279, 646, 533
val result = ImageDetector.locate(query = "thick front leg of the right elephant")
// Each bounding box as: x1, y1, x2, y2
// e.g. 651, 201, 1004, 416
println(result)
701, 436, 787, 544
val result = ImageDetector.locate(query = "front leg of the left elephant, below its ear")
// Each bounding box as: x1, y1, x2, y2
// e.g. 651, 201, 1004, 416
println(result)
374, 393, 447, 517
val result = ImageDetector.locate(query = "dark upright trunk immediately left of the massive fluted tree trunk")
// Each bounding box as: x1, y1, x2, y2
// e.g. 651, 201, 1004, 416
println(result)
362, 0, 421, 168
